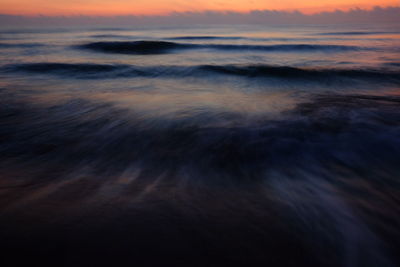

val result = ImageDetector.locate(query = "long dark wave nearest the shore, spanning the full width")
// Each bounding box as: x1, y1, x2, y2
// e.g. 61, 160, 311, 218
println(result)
2, 63, 400, 84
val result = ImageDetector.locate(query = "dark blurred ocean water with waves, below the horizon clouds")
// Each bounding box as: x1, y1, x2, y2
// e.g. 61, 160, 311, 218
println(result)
0, 25, 400, 267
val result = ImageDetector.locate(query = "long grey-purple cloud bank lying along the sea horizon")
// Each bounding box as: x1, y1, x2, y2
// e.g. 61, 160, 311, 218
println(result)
0, 7, 400, 27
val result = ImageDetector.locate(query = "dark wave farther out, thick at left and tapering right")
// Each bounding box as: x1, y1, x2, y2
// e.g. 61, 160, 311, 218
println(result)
77, 41, 366, 55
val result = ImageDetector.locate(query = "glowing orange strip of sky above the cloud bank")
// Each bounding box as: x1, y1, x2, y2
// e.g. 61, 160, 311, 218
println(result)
0, 0, 400, 15
